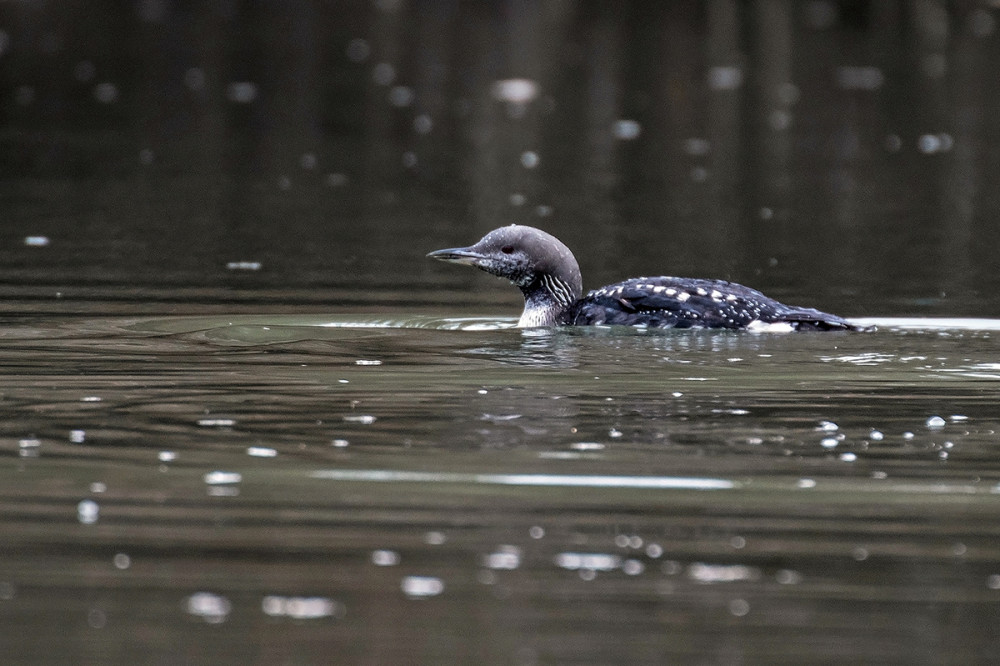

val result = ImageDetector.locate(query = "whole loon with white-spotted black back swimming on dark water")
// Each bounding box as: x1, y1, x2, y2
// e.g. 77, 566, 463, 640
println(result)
427, 224, 868, 331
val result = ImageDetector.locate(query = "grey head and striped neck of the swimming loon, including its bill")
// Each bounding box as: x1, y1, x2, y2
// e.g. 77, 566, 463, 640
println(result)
427, 224, 583, 316
